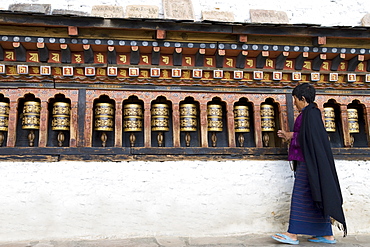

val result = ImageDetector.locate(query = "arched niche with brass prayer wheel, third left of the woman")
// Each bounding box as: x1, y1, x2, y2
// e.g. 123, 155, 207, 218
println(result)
207, 97, 229, 147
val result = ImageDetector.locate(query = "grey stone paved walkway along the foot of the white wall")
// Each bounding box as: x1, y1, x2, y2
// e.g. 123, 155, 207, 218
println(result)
0, 235, 370, 247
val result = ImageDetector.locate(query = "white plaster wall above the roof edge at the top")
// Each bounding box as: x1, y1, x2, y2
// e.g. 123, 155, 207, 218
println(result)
0, 0, 370, 26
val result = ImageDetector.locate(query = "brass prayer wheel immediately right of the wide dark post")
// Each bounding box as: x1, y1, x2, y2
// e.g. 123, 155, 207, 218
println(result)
94, 103, 114, 131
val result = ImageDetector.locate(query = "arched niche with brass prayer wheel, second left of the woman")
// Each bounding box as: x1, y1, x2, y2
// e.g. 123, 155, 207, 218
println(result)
234, 97, 256, 147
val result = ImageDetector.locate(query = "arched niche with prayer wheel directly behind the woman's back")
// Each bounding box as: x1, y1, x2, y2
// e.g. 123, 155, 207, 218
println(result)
322, 99, 344, 148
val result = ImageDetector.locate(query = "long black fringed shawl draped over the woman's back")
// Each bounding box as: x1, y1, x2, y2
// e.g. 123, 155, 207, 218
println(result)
299, 103, 347, 236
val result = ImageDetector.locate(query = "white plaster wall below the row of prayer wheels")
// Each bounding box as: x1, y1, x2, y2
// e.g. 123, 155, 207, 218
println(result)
0, 160, 370, 241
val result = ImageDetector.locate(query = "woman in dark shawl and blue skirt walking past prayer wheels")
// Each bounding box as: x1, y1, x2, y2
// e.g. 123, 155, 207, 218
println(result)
272, 83, 347, 244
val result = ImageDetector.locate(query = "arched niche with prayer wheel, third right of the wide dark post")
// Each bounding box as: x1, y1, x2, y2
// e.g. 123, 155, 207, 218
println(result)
150, 96, 173, 147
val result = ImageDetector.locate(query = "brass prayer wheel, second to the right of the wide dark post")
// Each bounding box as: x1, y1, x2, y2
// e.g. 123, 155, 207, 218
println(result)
123, 104, 143, 132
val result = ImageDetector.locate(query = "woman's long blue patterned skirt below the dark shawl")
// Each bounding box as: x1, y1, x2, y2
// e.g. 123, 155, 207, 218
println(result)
288, 162, 333, 236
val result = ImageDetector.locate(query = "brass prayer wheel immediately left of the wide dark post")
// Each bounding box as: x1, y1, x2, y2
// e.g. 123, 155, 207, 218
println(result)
51, 102, 71, 130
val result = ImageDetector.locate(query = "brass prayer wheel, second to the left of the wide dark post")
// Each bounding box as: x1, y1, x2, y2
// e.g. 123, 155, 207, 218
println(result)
22, 101, 41, 130
